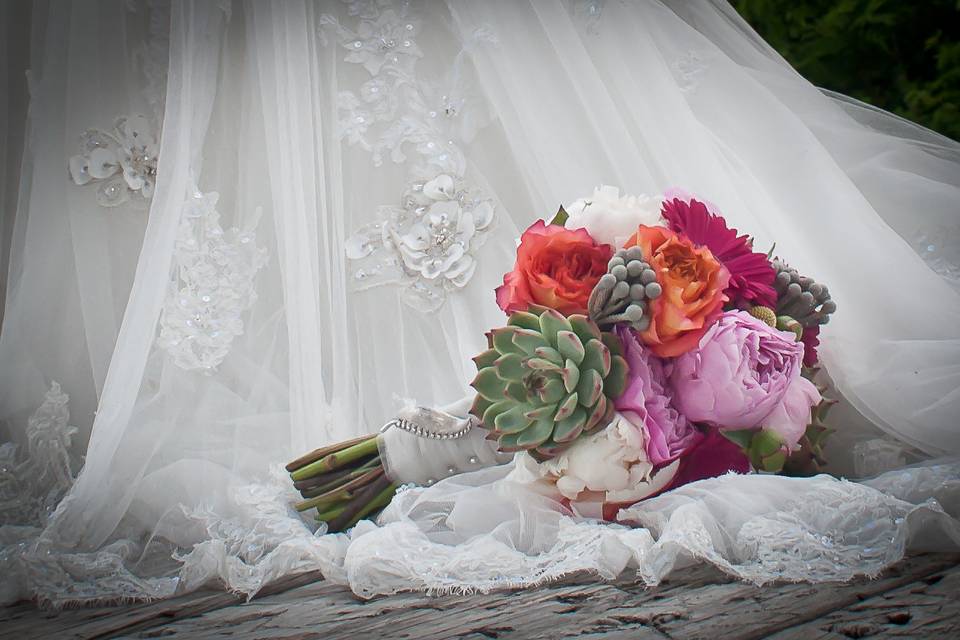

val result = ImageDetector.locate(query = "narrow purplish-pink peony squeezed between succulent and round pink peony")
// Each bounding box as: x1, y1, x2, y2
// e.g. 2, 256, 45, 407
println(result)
616, 325, 700, 466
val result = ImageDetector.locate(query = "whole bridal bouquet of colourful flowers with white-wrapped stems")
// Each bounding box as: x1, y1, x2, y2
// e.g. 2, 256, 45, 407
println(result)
288, 187, 836, 531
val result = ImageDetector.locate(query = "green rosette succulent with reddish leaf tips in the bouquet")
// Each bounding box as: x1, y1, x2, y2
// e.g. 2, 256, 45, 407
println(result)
470, 307, 627, 458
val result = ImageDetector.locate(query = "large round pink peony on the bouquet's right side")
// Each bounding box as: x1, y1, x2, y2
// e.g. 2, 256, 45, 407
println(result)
670, 311, 820, 447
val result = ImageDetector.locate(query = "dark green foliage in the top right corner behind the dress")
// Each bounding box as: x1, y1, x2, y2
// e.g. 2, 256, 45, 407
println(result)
732, 0, 960, 140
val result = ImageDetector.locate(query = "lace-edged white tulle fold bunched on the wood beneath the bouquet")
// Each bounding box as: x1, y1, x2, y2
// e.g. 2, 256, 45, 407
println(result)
344, 464, 960, 597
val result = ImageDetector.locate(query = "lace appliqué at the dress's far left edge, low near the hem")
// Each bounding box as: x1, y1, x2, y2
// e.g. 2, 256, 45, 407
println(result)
0, 382, 77, 526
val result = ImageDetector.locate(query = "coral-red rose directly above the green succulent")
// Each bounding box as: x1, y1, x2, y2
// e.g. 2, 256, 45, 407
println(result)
497, 220, 613, 315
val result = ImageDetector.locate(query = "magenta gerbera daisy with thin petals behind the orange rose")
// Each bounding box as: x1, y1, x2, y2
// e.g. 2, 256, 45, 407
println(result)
662, 198, 777, 309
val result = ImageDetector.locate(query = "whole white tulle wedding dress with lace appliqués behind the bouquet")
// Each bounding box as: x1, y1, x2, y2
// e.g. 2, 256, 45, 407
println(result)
0, 0, 960, 605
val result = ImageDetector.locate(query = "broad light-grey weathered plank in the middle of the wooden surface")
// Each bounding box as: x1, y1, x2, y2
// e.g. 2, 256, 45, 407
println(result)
122, 556, 958, 640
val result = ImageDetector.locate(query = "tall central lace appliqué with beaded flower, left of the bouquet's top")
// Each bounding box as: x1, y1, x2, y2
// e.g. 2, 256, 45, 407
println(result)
321, 0, 495, 312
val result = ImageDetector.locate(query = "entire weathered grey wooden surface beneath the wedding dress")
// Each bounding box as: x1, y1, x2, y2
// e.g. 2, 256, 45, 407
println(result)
0, 555, 960, 640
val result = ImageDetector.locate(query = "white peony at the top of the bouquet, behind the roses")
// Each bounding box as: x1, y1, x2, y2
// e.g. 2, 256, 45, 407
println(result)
564, 185, 663, 247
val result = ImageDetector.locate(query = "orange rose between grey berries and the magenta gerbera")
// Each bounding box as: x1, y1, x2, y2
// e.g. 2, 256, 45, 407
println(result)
625, 225, 730, 358
